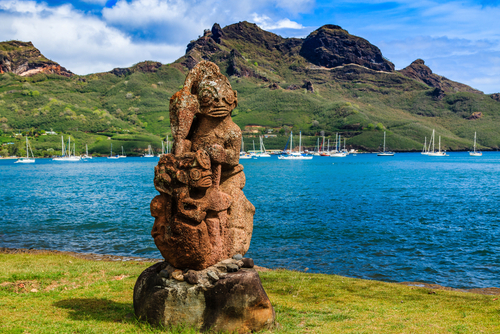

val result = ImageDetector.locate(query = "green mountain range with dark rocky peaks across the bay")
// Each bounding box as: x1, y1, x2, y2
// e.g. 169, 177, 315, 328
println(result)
0, 22, 500, 155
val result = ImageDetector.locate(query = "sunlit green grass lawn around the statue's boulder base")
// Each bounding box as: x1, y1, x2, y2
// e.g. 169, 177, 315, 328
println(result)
0, 254, 500, 334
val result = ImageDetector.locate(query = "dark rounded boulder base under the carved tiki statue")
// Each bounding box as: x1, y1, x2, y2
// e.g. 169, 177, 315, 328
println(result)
134, 260, 275, 333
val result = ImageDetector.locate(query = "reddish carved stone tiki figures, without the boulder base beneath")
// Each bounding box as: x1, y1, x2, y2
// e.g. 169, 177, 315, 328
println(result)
151, 61, 255, 270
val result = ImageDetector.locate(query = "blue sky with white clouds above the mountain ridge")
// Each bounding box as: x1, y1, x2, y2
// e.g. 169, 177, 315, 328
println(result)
0, 0, 500, 93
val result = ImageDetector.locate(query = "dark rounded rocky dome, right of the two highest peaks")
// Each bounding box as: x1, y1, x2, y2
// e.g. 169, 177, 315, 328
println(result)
300, 25, 394, 72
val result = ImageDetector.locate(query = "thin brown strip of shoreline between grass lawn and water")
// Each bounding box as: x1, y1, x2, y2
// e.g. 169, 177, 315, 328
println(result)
0, 247, 500, 295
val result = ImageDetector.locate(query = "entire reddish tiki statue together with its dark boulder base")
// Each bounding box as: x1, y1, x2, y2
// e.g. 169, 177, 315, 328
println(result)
134, 61, 275, 333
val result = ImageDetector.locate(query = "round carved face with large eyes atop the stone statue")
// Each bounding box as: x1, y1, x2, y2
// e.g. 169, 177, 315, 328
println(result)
198, 75, 238, 117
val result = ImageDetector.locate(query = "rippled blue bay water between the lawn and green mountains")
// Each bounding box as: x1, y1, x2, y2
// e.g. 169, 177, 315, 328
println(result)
0, 152, 500, 288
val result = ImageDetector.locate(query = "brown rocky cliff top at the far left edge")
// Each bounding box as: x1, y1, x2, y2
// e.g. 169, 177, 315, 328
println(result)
0, 41, 73, 77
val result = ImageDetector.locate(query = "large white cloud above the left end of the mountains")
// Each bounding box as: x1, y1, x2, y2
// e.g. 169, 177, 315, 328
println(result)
0, 1, 185, 74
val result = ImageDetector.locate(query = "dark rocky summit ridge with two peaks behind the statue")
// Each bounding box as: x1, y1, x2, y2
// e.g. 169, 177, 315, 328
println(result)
181, 22, 394, 78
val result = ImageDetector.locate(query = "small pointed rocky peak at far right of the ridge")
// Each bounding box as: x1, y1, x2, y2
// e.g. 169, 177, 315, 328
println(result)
399, 59, 483, 94
